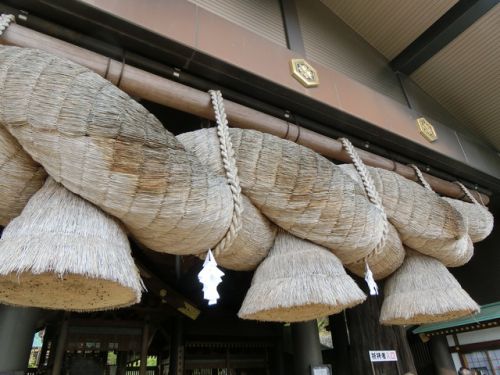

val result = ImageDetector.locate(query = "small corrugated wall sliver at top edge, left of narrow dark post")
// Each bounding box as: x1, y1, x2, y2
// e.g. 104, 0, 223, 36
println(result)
189, 0, 286, 47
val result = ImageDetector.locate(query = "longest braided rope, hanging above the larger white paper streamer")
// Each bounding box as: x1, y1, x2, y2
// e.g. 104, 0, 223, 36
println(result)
209, 90, 243, 256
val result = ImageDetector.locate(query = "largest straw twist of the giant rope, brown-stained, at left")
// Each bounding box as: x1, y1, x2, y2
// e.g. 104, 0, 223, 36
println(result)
0, 47, 232, 254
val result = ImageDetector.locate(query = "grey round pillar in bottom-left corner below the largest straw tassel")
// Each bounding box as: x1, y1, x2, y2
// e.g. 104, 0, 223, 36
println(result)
0, 306, 41, 373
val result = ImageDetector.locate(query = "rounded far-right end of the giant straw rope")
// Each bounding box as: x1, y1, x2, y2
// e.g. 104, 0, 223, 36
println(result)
443, 198, 494, 242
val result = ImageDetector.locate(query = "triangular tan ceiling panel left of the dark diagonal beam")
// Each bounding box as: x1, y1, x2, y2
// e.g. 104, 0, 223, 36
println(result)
321, 0, 458, 60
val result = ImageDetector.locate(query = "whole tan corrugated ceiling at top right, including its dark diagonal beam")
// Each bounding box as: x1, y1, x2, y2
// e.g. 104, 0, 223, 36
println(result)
321, 0, 500, 151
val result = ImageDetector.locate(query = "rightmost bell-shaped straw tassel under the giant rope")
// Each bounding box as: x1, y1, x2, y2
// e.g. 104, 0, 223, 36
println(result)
380, 250, 479, 325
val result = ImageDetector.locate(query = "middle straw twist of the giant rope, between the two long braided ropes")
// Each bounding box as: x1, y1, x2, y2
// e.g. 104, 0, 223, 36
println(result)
178, 129, 384, 264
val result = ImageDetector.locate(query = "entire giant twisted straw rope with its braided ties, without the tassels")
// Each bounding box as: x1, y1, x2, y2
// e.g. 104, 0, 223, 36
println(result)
0, 46, 493, 320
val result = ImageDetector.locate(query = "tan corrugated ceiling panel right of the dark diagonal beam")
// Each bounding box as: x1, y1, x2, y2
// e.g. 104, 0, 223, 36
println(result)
411, 4, 500, 150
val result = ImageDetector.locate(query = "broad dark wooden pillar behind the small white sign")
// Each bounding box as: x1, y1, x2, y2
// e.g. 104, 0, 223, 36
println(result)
346, 286, 417, 375
